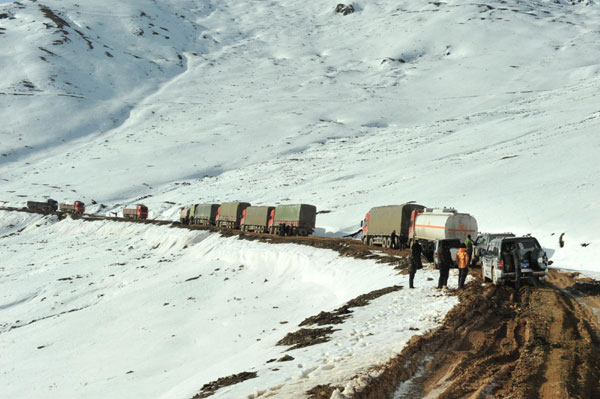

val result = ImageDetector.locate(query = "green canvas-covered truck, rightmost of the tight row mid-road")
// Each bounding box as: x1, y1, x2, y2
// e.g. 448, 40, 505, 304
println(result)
269, 204, 317, 236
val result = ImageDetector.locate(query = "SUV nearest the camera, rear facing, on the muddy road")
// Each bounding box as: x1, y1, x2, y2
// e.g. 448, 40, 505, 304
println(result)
481, 237, 548, 285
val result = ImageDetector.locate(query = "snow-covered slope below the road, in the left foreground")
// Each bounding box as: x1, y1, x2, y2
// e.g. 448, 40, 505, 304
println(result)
0, 211, 457, 399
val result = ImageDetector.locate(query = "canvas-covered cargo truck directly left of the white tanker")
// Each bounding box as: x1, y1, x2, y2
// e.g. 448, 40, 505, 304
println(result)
361, 203, 425, 248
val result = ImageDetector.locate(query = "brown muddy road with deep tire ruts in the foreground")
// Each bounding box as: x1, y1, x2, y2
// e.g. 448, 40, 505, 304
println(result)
352, 270, 600, 399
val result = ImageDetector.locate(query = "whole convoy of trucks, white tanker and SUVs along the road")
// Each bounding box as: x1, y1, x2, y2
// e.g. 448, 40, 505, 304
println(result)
21, 199, 548, 284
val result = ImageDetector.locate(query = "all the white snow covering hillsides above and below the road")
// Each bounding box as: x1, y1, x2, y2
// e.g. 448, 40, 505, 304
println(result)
0, 0, 600, 399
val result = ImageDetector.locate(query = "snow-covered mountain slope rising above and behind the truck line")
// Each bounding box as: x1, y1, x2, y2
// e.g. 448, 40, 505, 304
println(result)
0, 0, 600, 269
